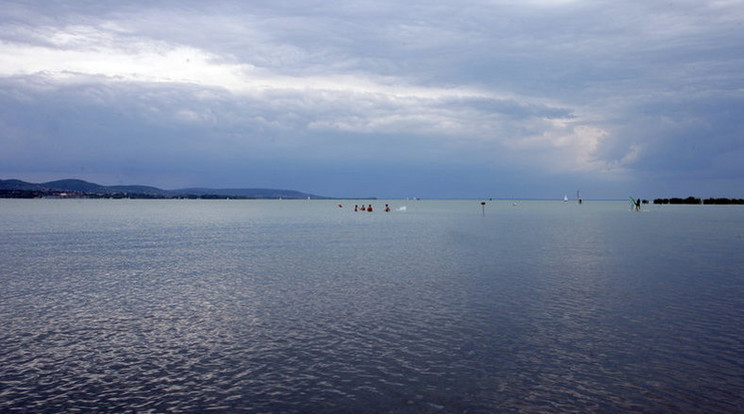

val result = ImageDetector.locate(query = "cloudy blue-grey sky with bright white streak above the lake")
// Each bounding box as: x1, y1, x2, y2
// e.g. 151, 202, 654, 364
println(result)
0, 0, 744, 199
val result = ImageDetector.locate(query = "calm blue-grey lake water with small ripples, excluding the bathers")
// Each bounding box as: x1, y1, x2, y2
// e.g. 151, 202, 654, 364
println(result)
0, 200, 744, 413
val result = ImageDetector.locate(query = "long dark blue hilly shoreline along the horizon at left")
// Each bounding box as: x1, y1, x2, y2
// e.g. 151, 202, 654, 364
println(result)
0, 179, 329, 199
